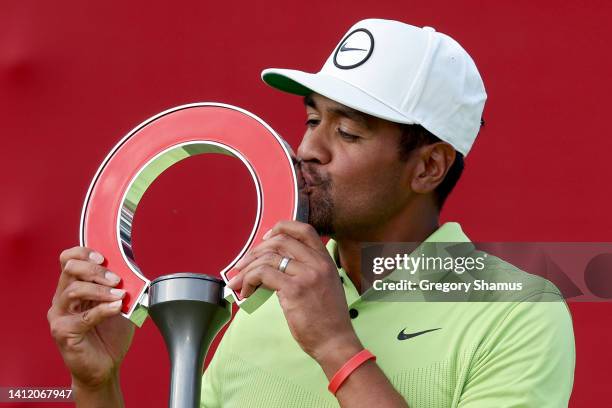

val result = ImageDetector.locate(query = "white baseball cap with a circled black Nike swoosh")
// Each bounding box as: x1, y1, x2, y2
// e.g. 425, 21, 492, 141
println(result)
261, 19, 487, 155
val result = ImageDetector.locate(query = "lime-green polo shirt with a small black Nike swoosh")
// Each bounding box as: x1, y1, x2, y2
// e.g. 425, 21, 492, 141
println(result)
201, 223, 575, 408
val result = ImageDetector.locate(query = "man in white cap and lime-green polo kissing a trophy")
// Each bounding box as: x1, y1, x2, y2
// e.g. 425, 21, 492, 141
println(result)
49, 20, 574, 407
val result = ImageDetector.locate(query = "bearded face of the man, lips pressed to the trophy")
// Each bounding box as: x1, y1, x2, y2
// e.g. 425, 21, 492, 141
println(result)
297, 94, 413, 239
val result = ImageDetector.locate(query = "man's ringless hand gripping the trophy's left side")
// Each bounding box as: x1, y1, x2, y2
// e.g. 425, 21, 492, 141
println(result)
47, 247, 134, 402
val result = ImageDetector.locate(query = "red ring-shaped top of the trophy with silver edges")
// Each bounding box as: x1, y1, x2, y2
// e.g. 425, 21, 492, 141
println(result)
80, 103, 303, 320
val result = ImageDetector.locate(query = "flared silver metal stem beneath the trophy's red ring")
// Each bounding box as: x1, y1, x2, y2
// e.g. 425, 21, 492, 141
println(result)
149, 273, 231, 408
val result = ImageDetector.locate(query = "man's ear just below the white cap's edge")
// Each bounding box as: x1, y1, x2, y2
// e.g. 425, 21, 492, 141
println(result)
410, 142, 457, 194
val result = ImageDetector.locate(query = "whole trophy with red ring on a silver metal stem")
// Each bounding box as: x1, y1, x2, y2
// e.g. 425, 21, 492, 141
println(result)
80, 103, 308, 408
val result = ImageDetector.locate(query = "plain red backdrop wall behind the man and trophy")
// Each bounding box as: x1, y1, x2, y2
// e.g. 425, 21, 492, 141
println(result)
0, 0, 612, 407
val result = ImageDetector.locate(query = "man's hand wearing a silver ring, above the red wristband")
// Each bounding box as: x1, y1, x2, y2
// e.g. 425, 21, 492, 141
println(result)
228, 221, 363, 371
